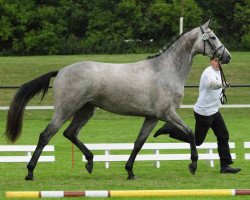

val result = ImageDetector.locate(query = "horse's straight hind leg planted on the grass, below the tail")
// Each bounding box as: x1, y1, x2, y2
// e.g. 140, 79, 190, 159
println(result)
25, 115, 66, 180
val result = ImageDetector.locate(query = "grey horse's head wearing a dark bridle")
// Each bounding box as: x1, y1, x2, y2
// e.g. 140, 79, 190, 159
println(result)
197, 20, 231, 64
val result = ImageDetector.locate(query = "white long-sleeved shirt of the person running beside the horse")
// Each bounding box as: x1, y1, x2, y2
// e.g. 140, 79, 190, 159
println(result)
194, 66, 222, 116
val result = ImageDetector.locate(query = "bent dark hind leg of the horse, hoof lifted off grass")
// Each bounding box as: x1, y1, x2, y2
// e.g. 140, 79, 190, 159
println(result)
63, 104, 95, 173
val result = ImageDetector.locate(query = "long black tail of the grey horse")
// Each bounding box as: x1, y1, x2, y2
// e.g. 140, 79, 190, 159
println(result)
5, 71, 58, 142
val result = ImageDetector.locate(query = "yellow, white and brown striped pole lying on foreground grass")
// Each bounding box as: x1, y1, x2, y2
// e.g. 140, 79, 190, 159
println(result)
6, 189, 250, 198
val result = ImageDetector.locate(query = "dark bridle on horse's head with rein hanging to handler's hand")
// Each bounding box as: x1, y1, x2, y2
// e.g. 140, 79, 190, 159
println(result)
200, 26, 229, 104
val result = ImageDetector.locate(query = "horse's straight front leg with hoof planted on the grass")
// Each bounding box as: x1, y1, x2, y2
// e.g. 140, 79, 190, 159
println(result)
125, 118, 158, 180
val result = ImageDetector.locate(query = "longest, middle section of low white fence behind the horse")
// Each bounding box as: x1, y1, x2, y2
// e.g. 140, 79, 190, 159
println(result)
82, 142, 236, 168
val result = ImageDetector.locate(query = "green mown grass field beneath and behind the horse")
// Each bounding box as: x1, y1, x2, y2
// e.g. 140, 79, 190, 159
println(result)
0, 53, 250, 200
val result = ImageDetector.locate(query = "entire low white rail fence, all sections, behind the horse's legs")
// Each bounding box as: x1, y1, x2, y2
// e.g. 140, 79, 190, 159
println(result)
0, 142, 250, 168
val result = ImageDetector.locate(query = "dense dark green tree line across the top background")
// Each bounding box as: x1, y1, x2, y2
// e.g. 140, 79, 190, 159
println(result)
0, 0, 250, 55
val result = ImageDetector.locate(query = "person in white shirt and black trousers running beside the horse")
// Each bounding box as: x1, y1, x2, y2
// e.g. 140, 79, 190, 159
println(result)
154, 58, 241, 174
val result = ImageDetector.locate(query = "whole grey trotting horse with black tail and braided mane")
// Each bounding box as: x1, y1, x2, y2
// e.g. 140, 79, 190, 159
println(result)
5, 21, 231, 180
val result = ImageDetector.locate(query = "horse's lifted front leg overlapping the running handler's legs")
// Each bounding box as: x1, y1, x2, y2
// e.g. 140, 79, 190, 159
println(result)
163, 111, 198, 174
